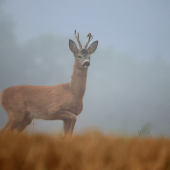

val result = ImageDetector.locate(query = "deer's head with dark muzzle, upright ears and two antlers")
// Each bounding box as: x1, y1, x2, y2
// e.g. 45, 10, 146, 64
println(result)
69, 30, 98, 69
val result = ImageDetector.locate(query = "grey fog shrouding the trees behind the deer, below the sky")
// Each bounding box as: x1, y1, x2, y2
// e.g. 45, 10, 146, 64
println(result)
0, 1, 170, 136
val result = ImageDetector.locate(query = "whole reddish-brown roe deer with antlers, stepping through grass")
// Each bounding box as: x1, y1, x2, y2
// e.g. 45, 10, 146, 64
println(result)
1, 30, 98, 136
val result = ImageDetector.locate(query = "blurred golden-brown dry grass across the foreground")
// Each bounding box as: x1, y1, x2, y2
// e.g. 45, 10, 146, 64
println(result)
0, 132, 170, 170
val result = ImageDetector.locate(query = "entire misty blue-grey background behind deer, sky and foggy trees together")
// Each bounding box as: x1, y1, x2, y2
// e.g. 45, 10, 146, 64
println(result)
0, 0, 170, 136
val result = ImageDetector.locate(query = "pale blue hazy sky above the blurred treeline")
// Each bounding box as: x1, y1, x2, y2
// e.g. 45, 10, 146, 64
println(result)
5, 0, 170, 59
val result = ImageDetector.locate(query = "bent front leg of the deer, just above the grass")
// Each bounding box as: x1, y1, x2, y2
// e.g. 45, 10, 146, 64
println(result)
56, 111, 77, 136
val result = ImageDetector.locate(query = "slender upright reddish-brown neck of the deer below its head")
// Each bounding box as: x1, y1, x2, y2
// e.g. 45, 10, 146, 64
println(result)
70, 63, 87, 99
